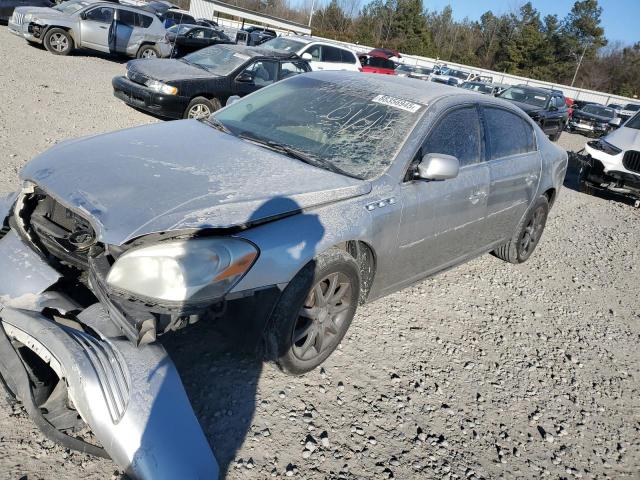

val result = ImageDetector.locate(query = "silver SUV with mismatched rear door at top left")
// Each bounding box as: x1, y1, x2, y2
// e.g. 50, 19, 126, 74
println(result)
9, 0, 165, 57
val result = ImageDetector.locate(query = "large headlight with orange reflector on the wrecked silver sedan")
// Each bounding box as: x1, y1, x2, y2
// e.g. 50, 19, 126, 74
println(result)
107, 238, 258, 303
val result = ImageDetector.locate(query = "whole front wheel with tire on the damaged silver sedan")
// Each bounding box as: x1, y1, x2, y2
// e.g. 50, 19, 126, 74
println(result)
265, 248, 360, 375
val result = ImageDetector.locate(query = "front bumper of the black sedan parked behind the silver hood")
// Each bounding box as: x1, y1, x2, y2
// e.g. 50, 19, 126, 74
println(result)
111, 77, 189, 119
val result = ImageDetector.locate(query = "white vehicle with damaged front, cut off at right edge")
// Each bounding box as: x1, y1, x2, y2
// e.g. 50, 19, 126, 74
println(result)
578, 113, 640, 207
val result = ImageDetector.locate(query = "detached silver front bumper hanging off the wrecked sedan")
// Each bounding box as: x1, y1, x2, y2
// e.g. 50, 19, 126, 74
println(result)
0, 231, 218, 479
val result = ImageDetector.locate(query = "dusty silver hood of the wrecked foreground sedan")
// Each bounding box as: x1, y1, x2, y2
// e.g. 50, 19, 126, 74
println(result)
21, 120, 371, 245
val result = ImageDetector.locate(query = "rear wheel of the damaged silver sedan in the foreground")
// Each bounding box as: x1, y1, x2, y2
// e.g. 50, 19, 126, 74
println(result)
493, 195, 549, 263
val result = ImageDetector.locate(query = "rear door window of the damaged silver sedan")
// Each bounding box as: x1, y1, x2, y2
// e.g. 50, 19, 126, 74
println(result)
482, 107, 536, 160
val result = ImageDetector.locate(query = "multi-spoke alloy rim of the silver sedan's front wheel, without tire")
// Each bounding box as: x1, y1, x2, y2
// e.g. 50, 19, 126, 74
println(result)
292, 272, 352, 360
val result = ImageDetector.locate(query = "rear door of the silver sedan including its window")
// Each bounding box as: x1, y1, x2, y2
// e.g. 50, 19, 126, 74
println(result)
482, 106, 542, 243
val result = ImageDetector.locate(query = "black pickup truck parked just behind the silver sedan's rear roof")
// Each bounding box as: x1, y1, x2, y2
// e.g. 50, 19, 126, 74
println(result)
498, 85, 569, 142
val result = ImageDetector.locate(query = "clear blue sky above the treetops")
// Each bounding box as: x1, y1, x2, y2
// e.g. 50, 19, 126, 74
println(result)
423, 0, 640, 44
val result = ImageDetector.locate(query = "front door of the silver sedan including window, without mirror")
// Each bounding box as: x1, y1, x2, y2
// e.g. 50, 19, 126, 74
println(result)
390, 105, 489, 288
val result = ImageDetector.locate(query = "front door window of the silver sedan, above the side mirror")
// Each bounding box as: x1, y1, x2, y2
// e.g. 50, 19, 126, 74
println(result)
422, 107, 482, 167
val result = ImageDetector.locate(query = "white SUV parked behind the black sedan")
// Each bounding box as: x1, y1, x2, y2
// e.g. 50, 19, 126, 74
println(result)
260, 35, 361, 72
